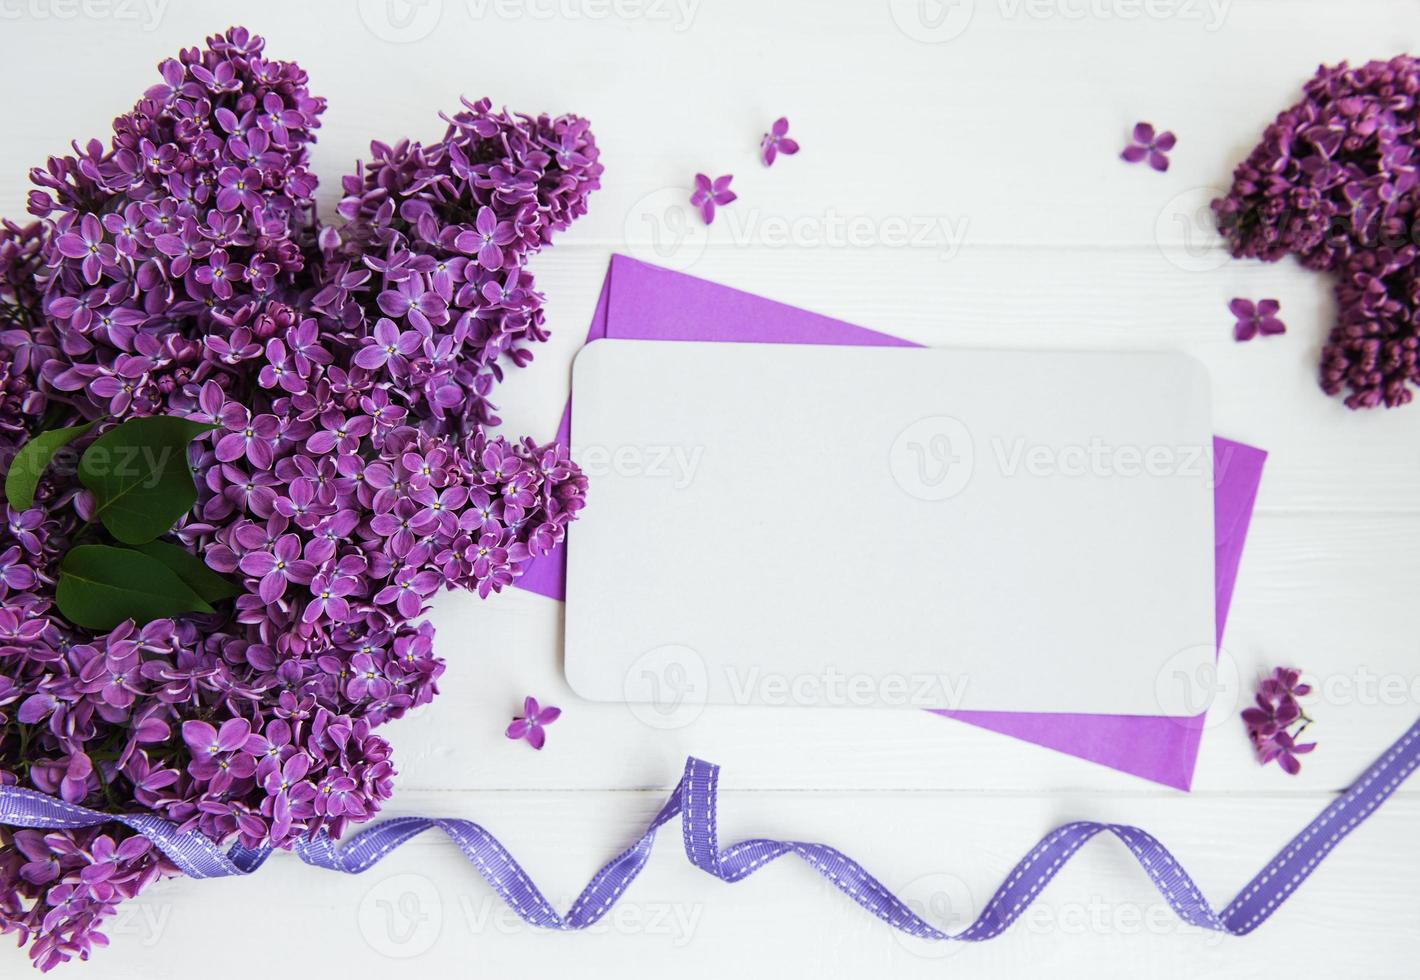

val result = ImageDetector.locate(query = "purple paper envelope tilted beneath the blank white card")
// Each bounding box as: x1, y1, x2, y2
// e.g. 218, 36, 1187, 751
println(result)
517, 256, 1267, 790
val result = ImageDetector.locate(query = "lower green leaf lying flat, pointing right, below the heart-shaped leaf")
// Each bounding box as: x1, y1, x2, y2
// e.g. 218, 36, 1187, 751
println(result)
54, 544, 212, 629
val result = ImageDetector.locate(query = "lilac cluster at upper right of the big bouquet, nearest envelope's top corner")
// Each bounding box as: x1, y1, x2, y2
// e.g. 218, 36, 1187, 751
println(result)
311, 99, 602, 432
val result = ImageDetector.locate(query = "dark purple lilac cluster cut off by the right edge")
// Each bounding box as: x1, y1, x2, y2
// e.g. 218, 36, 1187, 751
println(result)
1213, 55, 1420, 409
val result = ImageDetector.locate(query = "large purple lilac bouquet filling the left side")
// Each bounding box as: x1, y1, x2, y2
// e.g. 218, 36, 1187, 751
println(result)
0, 28, 602, 969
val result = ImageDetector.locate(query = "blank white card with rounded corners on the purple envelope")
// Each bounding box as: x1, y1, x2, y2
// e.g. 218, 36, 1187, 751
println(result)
567, 339, 1216, 716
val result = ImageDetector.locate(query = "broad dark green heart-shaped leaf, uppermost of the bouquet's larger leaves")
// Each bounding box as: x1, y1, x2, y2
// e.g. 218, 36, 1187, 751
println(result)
80, 415, 217, 544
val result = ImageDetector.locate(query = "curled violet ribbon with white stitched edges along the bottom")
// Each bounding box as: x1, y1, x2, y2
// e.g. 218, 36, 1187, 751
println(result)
0, 712, 1420, 942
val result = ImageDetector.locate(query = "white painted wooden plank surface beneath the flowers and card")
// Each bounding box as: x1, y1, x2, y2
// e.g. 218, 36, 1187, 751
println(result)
0, 0, 1420, 980
